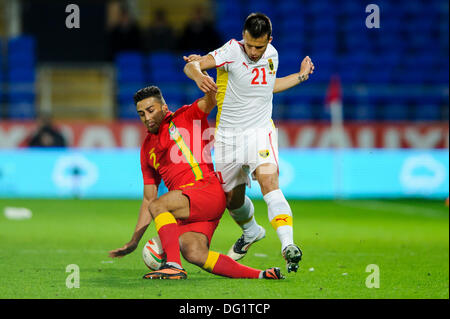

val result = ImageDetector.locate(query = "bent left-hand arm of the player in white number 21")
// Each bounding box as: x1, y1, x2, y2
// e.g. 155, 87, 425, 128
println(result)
183, 54, 217, 93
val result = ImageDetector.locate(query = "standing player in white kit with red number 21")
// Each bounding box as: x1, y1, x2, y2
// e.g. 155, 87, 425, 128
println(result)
184, 13, 314, 272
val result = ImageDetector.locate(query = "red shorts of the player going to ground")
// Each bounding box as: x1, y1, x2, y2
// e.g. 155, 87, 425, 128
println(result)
177, 176, 226, 244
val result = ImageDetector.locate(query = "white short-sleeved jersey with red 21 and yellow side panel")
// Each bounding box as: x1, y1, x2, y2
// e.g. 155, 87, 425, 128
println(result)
209, 39, 278, 134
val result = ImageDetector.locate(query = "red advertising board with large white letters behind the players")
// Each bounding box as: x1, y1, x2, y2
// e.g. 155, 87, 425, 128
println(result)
0, 122, 449, 149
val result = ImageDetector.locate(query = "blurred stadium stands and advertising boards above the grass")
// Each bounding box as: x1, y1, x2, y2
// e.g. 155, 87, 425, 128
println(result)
0, 0, 449, 198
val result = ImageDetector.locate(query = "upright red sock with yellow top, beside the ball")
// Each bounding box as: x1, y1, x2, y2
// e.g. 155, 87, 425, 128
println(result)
155, 212, 181, 266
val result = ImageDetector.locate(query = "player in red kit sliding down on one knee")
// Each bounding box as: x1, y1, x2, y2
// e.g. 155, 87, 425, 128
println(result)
109, 86, 283, 279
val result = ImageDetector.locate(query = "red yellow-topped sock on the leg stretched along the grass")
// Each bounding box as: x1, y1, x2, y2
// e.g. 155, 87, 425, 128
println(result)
203, 251, 261, 279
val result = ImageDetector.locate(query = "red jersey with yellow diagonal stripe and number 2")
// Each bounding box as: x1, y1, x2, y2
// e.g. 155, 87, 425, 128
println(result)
141, 100, 218, 190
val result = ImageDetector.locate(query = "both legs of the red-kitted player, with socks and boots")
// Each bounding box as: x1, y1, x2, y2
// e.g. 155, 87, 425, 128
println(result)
144, 191, 283, 279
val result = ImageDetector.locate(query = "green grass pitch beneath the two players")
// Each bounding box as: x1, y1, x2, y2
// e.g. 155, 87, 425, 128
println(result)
0, 200, 449, 299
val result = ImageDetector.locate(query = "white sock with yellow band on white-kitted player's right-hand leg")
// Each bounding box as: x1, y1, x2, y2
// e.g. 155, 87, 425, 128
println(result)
264, 189, 294, 251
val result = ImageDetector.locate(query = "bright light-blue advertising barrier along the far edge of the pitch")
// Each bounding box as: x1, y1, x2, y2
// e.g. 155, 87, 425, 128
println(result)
0, 149, 449, 199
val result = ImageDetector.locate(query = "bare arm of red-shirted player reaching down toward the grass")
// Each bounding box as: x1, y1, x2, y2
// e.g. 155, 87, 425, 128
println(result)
109, 185, 158, 258
